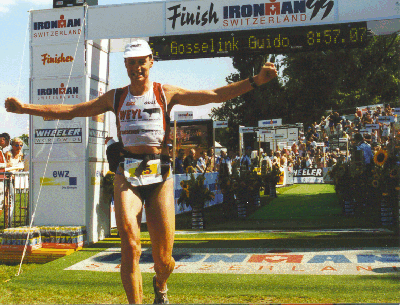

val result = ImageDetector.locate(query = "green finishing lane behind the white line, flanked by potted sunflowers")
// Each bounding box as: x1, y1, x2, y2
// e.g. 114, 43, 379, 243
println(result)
172, 184, 379, 231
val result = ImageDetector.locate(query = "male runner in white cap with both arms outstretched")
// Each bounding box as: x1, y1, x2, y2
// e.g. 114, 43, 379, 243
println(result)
5, 39, 277, 303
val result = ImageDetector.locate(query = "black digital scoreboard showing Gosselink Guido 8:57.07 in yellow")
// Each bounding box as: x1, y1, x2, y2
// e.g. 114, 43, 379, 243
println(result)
149, 22, 367, 60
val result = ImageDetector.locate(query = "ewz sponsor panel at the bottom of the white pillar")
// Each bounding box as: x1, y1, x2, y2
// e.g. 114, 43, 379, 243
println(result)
30, 161, 87, 226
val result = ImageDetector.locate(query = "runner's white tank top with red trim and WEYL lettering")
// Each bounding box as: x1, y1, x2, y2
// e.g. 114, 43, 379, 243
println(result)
116, 83, 166, 147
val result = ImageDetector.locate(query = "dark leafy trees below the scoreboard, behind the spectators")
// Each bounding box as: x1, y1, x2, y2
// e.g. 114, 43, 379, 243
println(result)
212, 34, 400, 148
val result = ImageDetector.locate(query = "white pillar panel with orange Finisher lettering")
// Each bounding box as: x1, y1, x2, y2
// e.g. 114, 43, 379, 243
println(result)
32, 43, 85, 78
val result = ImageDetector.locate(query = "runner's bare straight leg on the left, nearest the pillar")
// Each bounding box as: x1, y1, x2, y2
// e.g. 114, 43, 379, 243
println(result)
114, 172, 143, 304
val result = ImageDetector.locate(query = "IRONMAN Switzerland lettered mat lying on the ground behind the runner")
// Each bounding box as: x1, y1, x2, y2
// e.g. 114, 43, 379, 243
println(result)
65, 248, 400, 276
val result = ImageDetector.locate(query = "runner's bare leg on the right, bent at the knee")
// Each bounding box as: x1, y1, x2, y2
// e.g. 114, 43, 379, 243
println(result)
145, 179, 175, 290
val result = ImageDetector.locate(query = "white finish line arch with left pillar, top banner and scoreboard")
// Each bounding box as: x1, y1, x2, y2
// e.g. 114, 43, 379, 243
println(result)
30, 0, 400, 242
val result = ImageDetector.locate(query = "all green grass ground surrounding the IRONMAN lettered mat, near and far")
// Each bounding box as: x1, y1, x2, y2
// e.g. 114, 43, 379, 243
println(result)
0, 185, 400, 304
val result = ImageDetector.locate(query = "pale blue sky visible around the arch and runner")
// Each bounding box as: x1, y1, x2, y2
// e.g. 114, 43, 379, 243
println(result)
0, 0, 236, 137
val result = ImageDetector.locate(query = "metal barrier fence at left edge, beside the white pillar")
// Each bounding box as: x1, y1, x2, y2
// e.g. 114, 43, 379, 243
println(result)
0, 172, 29, 229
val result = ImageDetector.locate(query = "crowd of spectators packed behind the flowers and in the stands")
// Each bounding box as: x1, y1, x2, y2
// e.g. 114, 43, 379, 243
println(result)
175, 104, 393, 174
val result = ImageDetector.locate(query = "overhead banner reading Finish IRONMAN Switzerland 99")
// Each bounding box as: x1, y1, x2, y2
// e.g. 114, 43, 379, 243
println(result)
165, 0, 335, 34
